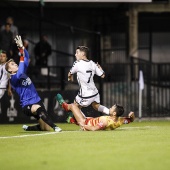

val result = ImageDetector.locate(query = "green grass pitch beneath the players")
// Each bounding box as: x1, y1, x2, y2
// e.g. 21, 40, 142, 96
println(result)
0, 121, 170, 170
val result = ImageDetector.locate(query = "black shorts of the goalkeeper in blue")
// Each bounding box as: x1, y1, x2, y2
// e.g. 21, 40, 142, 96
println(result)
22, 100, 45, 120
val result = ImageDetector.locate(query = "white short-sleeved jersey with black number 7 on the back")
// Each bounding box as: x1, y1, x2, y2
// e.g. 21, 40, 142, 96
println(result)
70, 60, 104, 98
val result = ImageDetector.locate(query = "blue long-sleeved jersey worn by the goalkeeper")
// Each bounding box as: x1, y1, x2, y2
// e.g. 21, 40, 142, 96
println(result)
10, 49, 41, 107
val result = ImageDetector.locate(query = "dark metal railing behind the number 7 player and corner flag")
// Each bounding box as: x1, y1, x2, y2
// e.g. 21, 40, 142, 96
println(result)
30, 62, 170, 117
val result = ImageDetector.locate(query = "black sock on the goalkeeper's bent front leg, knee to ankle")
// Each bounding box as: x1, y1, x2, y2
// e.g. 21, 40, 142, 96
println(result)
36, 107, 56, 129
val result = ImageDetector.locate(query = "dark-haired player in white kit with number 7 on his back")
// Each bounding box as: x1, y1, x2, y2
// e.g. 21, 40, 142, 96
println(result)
68, 46, 109, 122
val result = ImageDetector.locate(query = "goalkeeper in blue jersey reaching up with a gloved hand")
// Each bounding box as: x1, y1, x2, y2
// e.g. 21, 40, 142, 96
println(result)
5, 35, 62, 132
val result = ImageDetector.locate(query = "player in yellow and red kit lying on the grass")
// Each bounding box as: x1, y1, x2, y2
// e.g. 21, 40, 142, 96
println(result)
57, 94, 135, 131
